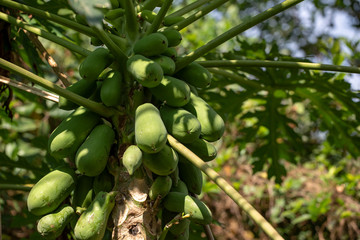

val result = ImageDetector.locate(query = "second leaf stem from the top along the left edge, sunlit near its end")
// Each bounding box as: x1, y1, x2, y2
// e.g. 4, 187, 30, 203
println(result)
0, 12, 90, 56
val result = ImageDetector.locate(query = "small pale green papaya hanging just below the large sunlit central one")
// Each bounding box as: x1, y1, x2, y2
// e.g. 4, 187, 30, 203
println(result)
122, 145, 142, 175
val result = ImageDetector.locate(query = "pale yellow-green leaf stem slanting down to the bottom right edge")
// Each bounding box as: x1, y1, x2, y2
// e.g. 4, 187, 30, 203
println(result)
168, 135, 283, 240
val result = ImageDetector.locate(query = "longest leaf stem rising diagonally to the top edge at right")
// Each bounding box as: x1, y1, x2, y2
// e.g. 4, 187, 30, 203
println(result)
175, 0, 303, 72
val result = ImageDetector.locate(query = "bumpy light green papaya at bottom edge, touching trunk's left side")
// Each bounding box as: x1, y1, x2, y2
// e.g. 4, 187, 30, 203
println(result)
74, 192, 116, 240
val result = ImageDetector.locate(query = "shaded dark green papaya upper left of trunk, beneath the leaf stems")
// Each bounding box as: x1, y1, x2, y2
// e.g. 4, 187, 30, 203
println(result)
100, 71, 123, 107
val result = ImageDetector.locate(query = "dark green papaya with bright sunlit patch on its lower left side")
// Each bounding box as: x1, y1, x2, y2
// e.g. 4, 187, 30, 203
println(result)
75, 124, 115, 177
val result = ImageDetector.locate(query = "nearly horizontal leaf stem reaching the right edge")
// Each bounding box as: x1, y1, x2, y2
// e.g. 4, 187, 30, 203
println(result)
197, 60, 360, 73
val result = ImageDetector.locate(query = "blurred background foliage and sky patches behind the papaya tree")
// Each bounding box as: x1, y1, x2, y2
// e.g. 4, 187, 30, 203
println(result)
0, 0, 360, 240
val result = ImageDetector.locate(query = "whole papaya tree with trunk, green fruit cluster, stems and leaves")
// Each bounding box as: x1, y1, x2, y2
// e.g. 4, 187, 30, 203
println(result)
0, 0, 360, 240
